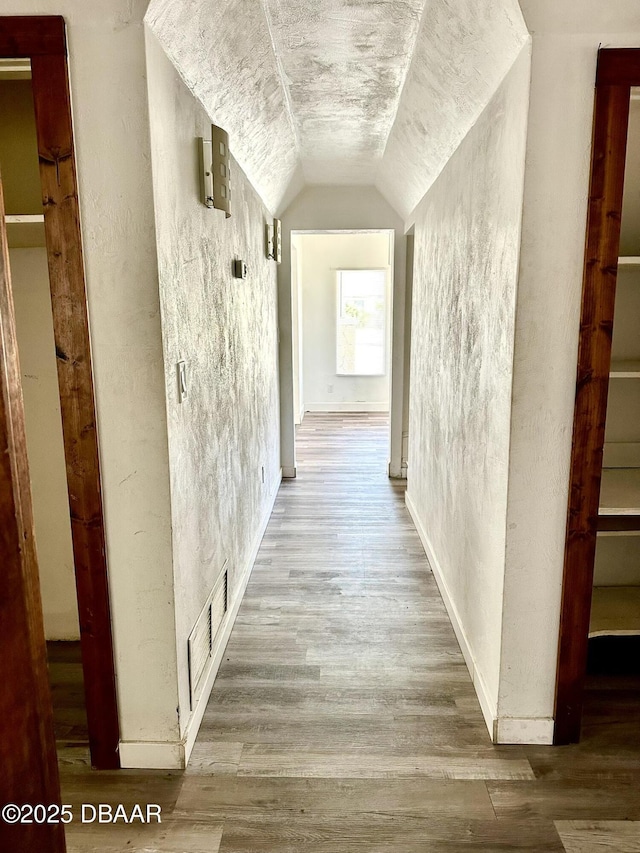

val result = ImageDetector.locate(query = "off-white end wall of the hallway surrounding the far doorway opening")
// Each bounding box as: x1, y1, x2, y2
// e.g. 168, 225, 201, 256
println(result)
278, 186, 406, 477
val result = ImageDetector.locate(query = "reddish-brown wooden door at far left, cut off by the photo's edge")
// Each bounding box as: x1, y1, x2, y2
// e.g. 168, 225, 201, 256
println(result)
0, 175, 66, 853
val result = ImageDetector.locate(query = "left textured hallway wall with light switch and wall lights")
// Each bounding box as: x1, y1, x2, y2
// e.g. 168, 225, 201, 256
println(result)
147, 34, 280, 732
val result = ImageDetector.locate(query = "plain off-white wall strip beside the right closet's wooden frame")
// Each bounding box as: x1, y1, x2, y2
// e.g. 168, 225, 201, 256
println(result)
498, 11, 640, 740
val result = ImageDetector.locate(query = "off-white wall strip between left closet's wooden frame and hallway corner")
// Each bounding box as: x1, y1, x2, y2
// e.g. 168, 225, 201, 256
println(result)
2, 0, 178, 743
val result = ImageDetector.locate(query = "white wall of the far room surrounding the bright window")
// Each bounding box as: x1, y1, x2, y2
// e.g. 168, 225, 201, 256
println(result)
292, 232, 393, 412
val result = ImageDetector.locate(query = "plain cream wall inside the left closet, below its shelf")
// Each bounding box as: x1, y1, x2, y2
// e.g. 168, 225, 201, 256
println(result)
9, 248, 80, 640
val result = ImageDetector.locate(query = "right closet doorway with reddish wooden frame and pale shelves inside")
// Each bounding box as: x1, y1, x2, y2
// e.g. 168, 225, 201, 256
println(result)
554, 49, 640, 744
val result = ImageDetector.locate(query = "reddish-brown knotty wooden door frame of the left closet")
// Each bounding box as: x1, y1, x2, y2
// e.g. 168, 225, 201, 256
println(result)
0, 16, 120, 769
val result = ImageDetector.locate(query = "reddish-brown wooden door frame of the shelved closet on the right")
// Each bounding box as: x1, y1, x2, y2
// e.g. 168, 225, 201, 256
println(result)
554, 48, 640, 744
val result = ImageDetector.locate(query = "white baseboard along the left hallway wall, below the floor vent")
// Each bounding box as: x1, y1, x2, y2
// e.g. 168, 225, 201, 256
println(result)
120, 469, 283, 770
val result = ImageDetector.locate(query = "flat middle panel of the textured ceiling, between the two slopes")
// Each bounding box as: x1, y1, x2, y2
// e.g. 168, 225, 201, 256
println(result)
265, 0, 425, 184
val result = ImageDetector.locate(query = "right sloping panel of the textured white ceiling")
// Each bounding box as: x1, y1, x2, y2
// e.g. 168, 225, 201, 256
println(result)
376, 0, 529, 219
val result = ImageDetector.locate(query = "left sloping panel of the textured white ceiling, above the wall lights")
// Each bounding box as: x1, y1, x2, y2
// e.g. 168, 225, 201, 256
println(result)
145, 0, 298, 210
